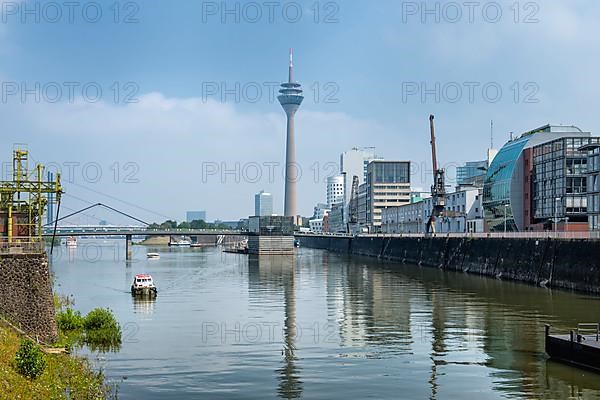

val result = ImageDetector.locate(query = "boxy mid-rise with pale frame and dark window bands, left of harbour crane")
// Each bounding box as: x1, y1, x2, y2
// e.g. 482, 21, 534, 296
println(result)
366, 160, 410, 232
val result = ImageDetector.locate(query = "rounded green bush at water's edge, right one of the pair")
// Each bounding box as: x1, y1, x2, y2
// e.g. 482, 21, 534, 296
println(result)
83, 308, 121, 351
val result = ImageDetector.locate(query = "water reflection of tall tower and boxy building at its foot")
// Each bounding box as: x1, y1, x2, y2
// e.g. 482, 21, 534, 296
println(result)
248, 256, 303, 399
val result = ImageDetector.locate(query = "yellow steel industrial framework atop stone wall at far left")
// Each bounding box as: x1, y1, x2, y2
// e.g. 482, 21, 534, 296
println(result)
0, 146, 63, 245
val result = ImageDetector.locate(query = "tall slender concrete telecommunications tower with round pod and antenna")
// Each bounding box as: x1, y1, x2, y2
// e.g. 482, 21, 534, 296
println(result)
277, 49, 304, 221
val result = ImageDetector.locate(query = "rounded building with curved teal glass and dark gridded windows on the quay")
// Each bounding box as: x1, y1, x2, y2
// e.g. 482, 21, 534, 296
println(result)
483, 125, 598, 232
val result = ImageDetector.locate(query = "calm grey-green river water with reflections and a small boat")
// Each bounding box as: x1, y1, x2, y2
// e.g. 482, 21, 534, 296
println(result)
52, 241, 600, 400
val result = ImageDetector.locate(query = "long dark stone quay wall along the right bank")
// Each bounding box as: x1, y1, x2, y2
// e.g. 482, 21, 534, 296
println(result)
296, 234, 600, 295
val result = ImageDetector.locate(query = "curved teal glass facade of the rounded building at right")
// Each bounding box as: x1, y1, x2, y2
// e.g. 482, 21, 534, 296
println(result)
483, 136, 530, 232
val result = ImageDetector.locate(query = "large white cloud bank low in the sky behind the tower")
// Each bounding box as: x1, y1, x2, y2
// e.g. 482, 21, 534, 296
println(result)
0, 93, 385, 218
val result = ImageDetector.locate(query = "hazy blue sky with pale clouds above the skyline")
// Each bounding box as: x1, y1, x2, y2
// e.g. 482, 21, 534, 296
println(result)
0, 0, 600, 223
